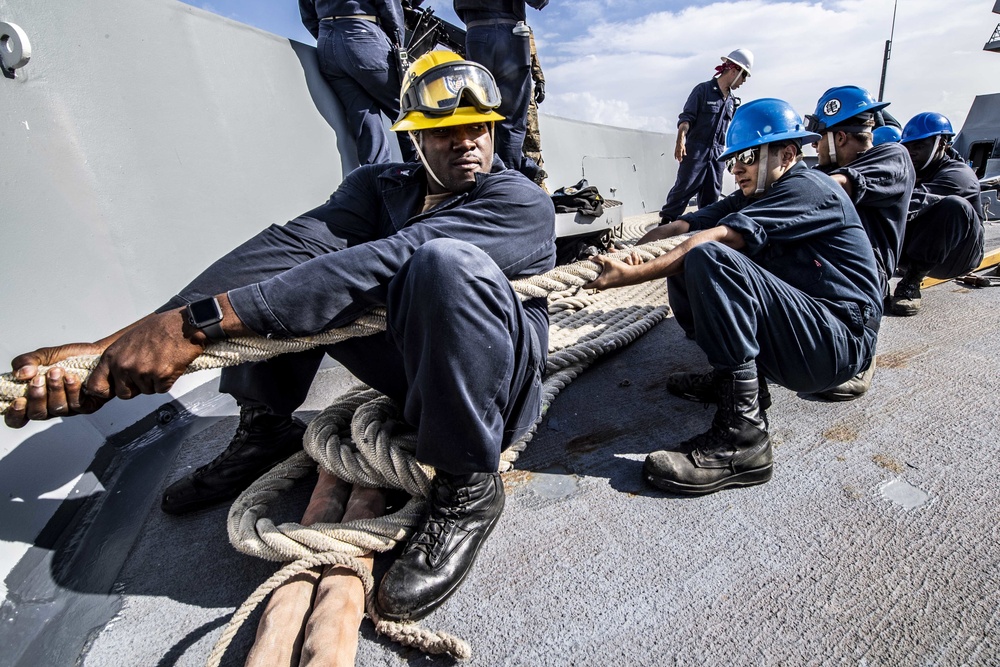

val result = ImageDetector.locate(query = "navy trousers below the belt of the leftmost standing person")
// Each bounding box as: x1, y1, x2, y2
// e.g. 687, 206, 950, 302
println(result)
316, 19, 416, 164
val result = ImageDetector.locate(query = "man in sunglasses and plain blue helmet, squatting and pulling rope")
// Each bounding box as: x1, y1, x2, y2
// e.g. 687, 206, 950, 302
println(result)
587, 99, 882, 494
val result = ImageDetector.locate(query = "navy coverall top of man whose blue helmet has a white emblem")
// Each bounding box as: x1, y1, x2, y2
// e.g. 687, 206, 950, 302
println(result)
828, 143, 916, 295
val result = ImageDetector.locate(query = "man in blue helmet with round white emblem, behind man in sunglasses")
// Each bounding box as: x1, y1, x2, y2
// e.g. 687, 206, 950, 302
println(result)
805, 86, 915, 401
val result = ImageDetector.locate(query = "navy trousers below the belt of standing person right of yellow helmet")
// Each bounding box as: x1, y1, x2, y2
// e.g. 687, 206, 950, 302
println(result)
465, 22, 531, 169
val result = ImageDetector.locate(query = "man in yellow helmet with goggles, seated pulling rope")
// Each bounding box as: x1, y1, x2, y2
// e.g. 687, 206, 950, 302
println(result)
5, 51, 555, 620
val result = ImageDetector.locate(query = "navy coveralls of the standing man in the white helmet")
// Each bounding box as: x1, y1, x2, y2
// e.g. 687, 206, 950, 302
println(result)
660, 79, 739, 222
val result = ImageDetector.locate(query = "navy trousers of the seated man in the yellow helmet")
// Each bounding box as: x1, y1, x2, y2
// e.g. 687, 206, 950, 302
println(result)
219, 239, 548, 474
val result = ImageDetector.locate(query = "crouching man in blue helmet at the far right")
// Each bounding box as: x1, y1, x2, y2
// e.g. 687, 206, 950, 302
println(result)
890, 112, 985, 316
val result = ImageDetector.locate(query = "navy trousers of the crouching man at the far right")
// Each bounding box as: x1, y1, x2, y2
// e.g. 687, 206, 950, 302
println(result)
899, 195, 985, 278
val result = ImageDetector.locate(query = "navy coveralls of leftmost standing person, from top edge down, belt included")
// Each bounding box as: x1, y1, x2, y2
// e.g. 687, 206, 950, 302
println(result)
299, 0, 416, 164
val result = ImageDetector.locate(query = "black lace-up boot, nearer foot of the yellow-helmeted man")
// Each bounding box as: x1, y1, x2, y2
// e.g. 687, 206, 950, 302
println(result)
376, 470, 505, 621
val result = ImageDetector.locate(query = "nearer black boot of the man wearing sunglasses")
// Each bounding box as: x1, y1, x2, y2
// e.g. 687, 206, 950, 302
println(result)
643, 373, 772, 495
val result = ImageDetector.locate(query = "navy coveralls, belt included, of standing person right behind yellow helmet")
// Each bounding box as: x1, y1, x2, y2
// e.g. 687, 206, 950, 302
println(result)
454, 0, 548, 175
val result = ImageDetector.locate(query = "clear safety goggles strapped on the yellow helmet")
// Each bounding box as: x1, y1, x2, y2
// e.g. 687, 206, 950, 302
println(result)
399, 61, 500, 116
